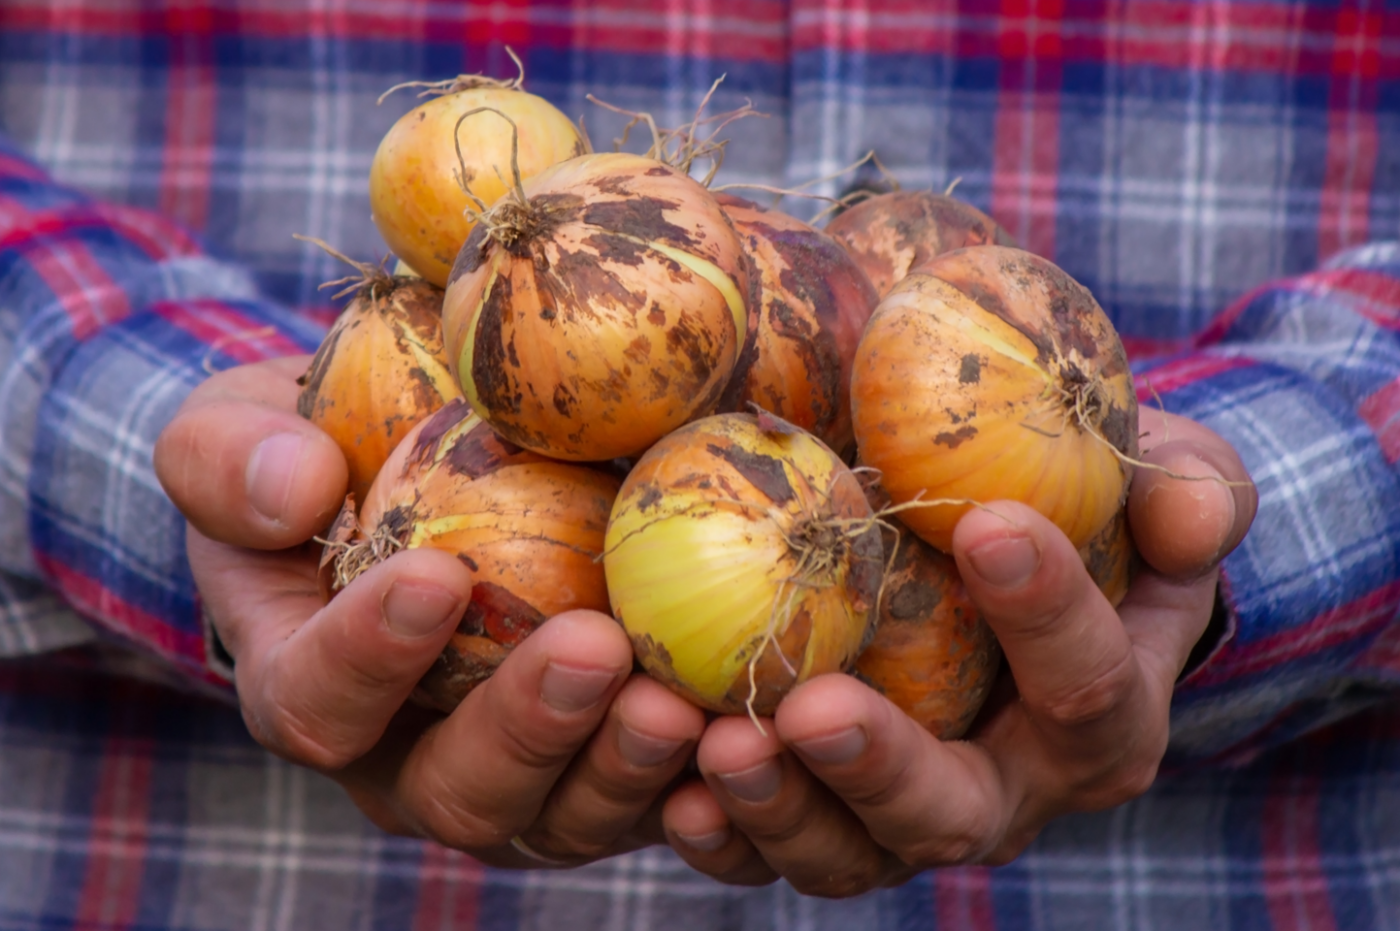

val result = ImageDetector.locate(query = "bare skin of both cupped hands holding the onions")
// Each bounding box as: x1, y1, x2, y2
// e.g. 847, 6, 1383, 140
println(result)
155, 357, 1257, 896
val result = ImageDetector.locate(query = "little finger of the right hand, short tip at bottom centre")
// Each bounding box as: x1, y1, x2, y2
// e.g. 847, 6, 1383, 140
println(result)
662, 780, 778, 886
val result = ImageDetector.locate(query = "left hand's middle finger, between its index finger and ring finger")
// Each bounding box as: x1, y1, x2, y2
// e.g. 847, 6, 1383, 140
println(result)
396, 610, 631, 850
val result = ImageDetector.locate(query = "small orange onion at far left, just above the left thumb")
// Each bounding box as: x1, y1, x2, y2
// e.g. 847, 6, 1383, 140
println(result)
297, 277, 462, 501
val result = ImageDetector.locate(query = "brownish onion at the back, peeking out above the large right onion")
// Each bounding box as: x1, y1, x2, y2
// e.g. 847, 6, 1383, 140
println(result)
826, 190, 1016, 297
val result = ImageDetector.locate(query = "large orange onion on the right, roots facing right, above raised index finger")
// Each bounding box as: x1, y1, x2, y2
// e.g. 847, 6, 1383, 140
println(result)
851, 246, 1138, 552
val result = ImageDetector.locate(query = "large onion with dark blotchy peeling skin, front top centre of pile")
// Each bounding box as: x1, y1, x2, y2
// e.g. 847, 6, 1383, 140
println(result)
442, 153, 749, 461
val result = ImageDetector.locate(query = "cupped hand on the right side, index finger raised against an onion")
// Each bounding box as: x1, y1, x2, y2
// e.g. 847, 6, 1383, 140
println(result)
664, 410, 1257, 896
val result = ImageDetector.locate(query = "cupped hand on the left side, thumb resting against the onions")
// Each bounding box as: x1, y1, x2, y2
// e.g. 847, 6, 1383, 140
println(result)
155, 357, 704, 867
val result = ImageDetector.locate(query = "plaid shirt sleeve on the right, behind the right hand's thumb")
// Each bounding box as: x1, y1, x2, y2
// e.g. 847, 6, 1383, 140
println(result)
1153, 242, 1400, 766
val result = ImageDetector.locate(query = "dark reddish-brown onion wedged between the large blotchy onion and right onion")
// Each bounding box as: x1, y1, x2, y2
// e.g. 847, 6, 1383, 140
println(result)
715, 193, 878, 452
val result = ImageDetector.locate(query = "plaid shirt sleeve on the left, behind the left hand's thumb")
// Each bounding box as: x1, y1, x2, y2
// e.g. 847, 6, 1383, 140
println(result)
0, 136, 322, 679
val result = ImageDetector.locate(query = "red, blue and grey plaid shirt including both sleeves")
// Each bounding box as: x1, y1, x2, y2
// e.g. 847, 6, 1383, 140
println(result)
0, 0, 1400, 931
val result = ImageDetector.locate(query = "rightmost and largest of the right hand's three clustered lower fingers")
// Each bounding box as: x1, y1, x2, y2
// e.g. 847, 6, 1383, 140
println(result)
774, 675, 1016, 878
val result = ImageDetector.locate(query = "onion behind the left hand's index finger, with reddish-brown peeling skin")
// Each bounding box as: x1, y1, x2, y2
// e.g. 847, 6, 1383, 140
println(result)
322, 398, 619, 711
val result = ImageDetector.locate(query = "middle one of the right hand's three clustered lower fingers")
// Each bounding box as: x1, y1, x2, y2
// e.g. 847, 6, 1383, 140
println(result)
696, 717, 886, 896
